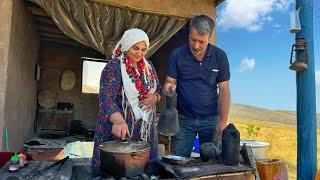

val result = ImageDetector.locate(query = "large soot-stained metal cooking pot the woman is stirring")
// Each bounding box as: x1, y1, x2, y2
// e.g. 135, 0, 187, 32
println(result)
99, 141, 150, 177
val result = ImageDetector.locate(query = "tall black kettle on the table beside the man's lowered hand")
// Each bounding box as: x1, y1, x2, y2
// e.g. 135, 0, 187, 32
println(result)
221, 123, 240, 166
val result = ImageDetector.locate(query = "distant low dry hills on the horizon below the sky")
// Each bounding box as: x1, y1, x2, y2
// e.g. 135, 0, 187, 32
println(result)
230, 104, 320, 127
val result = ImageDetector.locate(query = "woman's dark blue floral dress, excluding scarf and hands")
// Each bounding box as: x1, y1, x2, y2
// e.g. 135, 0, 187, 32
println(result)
92, 58, 161, 166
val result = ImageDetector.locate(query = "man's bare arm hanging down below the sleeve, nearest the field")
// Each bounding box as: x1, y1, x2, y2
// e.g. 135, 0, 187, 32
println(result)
215, 81, 230, 140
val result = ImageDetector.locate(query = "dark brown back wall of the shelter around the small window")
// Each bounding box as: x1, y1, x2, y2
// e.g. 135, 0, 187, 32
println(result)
39, 42, 103, 128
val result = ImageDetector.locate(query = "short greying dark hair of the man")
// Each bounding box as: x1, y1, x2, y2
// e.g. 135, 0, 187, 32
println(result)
189, 15, 215, 36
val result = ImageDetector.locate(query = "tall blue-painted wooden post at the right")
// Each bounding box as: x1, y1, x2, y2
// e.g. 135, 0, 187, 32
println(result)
296, 0, 317, 180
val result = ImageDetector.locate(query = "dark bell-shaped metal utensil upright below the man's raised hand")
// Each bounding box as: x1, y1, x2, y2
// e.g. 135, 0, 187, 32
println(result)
157, 92, 180, 153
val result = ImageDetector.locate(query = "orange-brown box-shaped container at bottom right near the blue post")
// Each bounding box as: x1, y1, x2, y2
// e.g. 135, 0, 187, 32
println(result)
256, 159, 288, 180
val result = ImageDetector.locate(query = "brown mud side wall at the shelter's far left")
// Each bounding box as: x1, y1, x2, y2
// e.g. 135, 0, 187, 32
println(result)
1, 0, 39, 151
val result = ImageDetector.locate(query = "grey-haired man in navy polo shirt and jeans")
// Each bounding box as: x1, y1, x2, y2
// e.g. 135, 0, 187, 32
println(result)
163, 15, 230, 157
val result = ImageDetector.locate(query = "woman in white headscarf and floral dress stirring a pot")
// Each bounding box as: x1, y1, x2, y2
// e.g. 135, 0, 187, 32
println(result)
92, 29, 161, 166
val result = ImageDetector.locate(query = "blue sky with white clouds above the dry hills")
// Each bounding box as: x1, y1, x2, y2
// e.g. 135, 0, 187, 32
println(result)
216, 0, 320, 112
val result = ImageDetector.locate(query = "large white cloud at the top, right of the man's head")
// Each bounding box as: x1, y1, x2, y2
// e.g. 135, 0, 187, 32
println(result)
218, 0, 293, 31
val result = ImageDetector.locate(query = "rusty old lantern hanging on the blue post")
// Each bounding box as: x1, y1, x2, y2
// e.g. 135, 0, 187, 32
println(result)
289, 38, 308, 71
